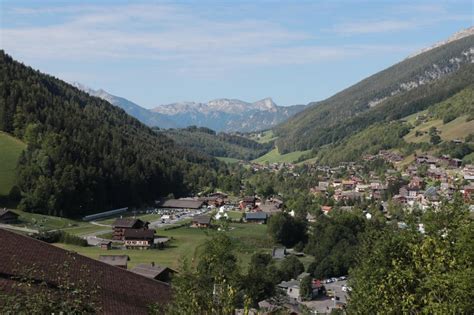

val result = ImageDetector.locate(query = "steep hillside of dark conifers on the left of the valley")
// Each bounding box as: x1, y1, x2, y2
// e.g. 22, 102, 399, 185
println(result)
0, 51, 218, 216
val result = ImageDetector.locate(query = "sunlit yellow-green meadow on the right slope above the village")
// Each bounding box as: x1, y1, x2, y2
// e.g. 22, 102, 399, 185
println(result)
404, 116, 474, 143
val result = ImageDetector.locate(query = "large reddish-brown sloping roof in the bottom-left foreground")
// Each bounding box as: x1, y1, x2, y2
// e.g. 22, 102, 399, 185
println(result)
0, 229, 171, 315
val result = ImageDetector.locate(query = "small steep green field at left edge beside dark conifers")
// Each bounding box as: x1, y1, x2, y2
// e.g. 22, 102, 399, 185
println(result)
0, 132, 26, 196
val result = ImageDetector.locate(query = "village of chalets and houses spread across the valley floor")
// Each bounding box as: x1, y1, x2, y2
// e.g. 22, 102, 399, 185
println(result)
0, 151, 474, 313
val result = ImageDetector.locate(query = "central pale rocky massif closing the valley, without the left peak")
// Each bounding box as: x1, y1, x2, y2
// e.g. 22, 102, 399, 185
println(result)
152, 98, 304, 132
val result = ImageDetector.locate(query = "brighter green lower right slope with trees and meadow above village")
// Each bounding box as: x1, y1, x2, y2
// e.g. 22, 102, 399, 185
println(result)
309, 84, 474, 165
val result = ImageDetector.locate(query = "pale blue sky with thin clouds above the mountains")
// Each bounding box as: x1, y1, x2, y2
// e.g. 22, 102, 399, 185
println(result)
0, 0, 474, 108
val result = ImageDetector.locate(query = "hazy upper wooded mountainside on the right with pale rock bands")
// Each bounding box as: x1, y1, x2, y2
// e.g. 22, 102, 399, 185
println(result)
274, 36, 474, 153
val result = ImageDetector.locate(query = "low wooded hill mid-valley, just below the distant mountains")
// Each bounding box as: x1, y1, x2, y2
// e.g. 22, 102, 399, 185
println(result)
160, 126, 273, 160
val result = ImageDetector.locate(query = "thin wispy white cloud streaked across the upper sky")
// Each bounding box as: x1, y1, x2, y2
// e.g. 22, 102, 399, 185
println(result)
1, 5, 422, 75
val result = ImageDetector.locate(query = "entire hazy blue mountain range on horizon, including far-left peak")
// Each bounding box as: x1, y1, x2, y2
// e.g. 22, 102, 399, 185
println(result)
72, 82, 305, 132
